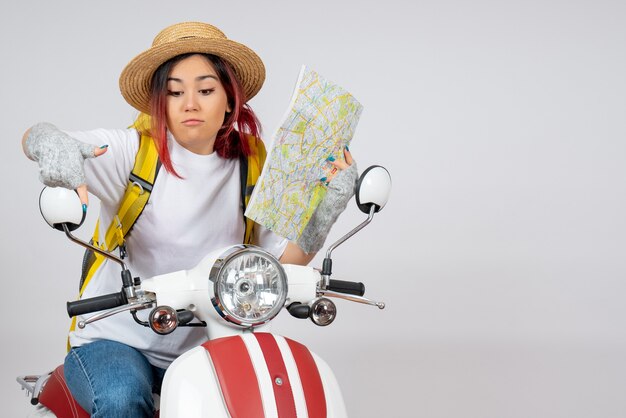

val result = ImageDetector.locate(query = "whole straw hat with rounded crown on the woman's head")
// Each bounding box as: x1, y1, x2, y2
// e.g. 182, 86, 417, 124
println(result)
120, 22, 265, 113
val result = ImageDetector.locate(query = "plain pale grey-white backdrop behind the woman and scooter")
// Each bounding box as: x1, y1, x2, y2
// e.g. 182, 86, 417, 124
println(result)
0, 0, 626, 418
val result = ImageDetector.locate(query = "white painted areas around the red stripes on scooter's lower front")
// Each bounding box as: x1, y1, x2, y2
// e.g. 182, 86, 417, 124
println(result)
161, 333, 347, 418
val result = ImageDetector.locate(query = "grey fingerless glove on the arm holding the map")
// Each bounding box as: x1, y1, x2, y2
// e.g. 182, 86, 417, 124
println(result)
296, 162, 359, 254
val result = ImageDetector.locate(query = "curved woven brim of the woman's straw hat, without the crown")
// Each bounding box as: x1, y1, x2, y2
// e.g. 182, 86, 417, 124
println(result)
119, 38, 265, 114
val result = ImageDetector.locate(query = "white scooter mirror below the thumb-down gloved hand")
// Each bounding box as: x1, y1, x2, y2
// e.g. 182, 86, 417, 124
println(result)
39, 187, 86, 231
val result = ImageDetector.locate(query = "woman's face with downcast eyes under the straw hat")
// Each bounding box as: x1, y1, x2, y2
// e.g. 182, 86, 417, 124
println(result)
167, 55, 231, 155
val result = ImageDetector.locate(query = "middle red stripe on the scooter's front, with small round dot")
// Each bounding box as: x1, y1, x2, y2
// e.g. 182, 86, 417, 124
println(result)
254, 333, 296, 418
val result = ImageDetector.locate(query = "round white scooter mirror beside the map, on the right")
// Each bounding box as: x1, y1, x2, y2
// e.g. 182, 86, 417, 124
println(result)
355, 165, 391, 215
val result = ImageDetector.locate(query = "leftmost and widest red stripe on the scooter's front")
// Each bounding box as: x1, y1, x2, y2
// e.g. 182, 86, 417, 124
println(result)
202, 336, 265, 418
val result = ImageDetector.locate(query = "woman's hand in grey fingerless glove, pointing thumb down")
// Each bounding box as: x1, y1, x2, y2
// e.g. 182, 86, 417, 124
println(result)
22, 123, 108, 209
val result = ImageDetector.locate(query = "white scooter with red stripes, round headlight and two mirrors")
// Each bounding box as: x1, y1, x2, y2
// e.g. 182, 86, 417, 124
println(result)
17, 166, 391, 418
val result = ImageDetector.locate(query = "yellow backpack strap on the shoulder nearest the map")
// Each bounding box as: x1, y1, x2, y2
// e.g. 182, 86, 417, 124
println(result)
239, 135, 267, 244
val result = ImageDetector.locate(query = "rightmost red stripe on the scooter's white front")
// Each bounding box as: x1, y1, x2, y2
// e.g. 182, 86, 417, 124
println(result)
285, 338, 326, 418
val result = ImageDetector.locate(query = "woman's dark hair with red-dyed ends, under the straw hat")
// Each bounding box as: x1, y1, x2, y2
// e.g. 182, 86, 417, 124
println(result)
150, 53, 261, 177
